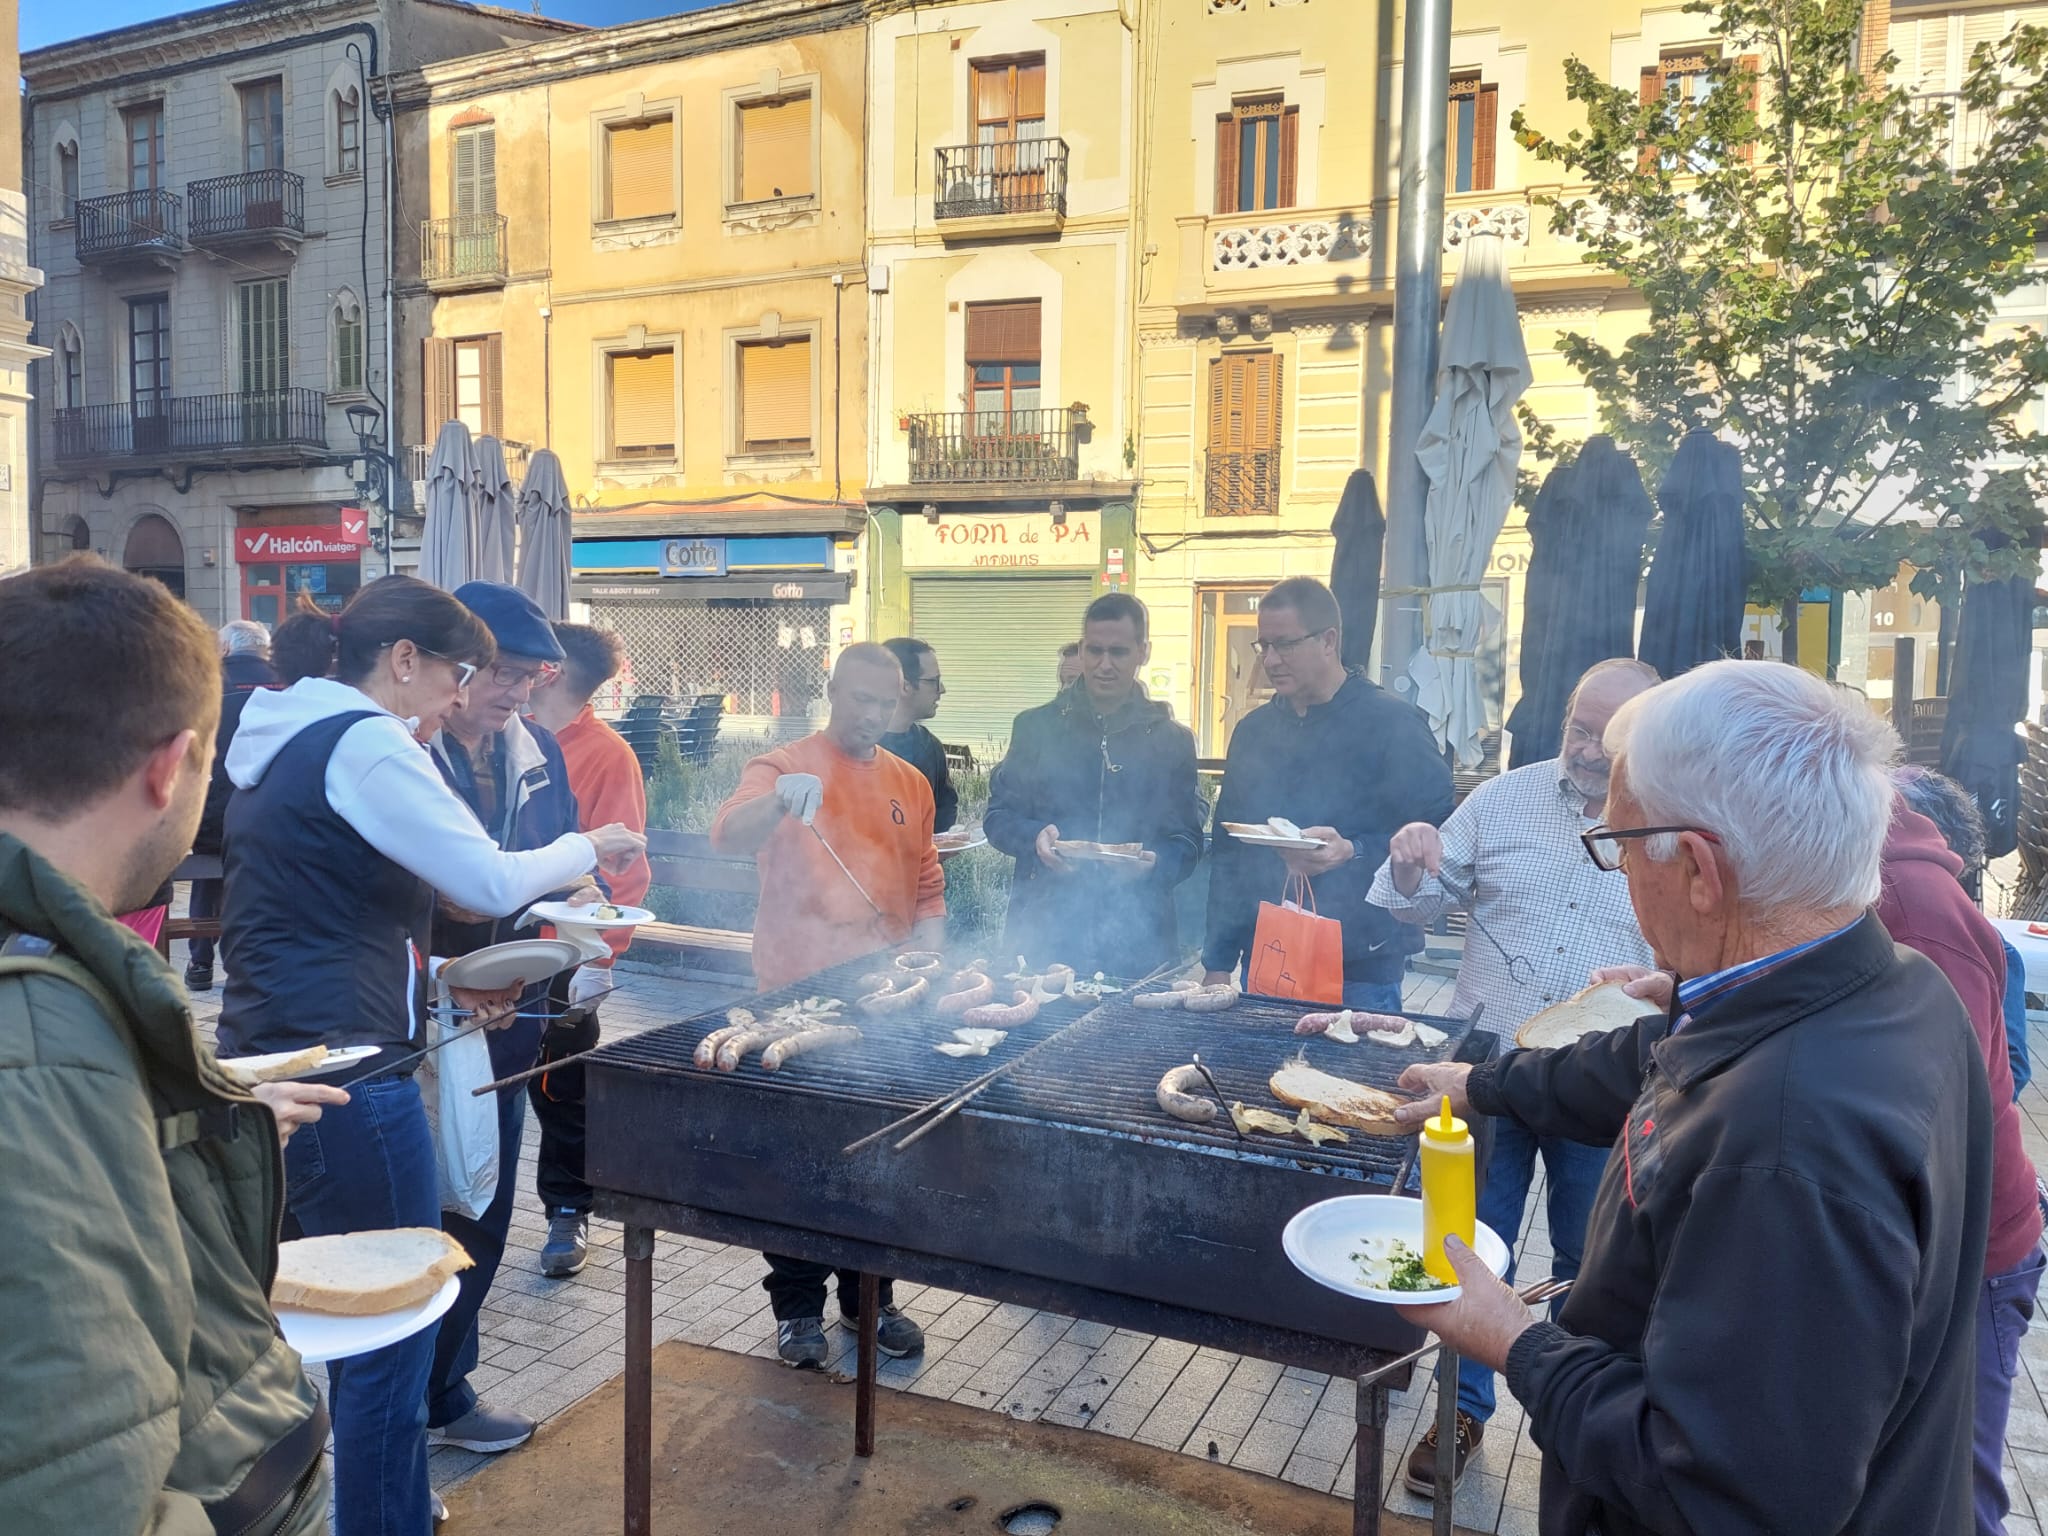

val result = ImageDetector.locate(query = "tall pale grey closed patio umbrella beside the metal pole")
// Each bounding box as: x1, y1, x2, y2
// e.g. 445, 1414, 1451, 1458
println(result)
1409, 236, 1530, 768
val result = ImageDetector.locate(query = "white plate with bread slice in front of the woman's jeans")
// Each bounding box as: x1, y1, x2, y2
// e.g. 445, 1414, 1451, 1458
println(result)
270, 1227, 469, 1364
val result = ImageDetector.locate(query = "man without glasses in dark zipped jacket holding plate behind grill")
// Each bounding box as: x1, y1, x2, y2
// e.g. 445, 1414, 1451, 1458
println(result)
983, 592, 1202, 977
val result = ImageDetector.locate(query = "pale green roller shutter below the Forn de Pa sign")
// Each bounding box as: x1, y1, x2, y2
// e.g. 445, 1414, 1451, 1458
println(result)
909, 575, 1096, 764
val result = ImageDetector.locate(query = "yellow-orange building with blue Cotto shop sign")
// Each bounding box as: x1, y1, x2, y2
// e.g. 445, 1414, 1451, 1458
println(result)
397, 0, 870, 731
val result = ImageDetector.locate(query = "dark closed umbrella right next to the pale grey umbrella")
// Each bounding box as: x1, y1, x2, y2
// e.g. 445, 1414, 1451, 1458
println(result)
1507, 432, 1653, 768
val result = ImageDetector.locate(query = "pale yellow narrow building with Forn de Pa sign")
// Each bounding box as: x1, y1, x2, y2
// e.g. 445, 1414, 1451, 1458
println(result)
864, 0, 1141, 754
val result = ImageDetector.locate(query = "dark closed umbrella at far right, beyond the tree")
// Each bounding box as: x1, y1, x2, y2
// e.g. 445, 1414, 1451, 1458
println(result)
1942, 557, 2034, 858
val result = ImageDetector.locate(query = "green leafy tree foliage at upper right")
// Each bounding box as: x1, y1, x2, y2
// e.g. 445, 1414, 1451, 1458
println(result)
1513, 0, 2048, 626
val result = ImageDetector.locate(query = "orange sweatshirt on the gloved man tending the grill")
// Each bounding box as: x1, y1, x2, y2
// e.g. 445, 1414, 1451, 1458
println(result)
711, 731, 946, 991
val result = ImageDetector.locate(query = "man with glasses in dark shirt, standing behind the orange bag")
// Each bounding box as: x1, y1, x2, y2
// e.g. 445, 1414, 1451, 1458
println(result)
1202, 575, 1452, 1014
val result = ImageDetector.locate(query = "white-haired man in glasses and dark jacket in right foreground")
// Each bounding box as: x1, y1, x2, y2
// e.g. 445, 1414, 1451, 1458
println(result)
1401, 662, 1991, 1536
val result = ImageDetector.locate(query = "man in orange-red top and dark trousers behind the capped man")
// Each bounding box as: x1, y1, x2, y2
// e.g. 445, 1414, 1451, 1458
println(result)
526, 625, 653, 1280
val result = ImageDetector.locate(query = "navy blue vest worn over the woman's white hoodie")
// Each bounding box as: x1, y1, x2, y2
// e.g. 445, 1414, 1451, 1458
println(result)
219, 711, 434, 1073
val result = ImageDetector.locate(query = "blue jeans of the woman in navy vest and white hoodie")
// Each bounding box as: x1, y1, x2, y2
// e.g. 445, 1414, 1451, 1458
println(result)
285, 1077, 440, 1536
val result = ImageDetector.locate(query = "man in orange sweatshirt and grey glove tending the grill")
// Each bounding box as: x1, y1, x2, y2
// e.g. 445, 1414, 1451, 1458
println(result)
711, 645, 946, 1370
